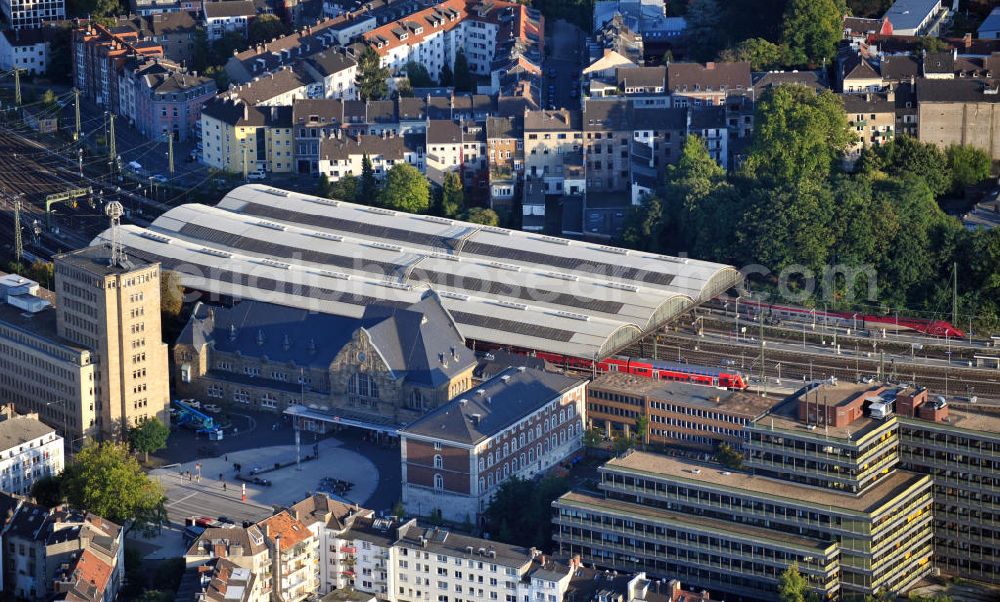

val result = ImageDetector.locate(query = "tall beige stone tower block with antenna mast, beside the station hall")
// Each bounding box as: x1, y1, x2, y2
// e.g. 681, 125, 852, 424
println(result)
54, 247, 170, 437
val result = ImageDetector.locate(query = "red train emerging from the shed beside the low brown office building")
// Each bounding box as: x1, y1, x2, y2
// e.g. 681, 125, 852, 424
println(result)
533, 351, 747, 391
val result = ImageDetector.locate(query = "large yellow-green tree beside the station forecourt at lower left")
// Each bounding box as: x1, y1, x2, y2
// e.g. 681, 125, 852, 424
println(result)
63, 443, 167, 534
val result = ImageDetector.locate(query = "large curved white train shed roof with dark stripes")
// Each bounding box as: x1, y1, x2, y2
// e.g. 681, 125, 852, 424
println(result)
95, 184, 740, 358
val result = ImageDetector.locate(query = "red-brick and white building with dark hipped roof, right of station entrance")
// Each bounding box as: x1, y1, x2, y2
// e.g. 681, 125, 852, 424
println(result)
400, 368, 586, 522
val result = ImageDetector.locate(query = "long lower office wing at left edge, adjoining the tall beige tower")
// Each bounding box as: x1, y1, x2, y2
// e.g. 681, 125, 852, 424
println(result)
0, 275, 99, 442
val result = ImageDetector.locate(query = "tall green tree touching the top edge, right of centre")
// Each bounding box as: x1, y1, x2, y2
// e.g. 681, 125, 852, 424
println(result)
782, 0, 846, 66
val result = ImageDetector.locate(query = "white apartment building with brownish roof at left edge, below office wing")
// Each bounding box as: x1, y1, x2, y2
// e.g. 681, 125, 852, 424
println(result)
0, 404, 64, 495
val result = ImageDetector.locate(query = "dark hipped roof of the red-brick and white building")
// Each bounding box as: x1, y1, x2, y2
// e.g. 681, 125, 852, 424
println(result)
400, 368, 586, 445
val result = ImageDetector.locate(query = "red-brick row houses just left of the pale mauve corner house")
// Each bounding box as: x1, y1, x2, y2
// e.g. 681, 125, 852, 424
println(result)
72, 23, 163, 109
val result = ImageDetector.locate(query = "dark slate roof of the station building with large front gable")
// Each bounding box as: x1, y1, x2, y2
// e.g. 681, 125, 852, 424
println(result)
177, 295, 475, 387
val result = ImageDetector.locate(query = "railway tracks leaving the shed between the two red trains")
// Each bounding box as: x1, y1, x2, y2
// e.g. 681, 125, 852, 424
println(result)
624, 333, 1000, 400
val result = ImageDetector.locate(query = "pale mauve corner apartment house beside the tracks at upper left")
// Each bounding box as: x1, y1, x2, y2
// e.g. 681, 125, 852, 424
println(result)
118, 59, 218, 142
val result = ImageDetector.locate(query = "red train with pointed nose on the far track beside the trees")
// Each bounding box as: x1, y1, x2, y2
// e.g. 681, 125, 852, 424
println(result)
720, 297, 965, 339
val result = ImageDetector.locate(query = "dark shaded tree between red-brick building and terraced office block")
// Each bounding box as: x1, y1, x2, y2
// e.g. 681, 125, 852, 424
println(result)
484, 475, 569, 551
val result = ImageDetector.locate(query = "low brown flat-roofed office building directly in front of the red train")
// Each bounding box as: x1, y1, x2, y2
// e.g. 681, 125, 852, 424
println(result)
587, 372, 775, 450
